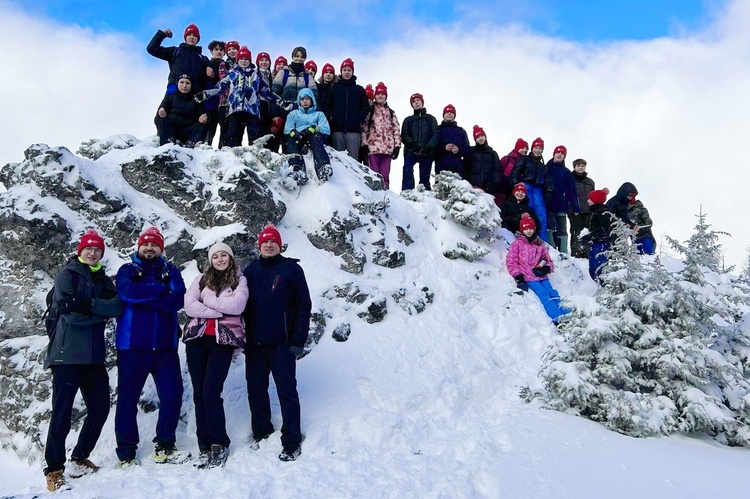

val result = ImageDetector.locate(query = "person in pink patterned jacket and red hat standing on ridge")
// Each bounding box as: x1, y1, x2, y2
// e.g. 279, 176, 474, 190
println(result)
362, 81, 401, 189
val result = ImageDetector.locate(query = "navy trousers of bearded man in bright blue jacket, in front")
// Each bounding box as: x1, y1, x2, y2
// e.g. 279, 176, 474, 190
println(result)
115, 349, 182, 461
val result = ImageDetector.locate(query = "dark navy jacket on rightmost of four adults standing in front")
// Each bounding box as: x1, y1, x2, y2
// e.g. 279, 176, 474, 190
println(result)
242, 255, 312, 347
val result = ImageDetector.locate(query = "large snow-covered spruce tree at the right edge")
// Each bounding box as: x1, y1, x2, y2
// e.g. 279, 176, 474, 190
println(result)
525, 219, 750, 446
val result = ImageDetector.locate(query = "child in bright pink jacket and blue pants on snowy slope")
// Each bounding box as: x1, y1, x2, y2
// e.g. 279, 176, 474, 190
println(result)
505, 213, 570, 324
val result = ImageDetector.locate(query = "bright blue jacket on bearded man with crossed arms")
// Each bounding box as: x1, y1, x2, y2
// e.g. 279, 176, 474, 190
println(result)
115, 255, 186, 350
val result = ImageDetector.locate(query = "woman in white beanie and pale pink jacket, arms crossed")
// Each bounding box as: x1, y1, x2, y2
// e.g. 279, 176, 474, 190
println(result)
182, 243, 248, 468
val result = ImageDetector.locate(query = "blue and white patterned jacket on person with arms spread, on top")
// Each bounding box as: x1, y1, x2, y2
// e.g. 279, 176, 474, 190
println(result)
206, 65, 281, 117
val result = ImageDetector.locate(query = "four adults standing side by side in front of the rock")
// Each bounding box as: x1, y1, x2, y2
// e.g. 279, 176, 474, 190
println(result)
44, 225, 312, 491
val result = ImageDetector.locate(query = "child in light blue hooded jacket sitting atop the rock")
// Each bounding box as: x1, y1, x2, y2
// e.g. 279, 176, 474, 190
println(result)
284, 88, 333, 185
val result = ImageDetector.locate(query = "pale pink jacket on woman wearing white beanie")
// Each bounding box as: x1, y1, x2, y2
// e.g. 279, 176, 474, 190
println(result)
182, 275, 249, 348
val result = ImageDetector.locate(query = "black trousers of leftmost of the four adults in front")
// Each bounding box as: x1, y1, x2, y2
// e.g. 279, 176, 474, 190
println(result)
44, 364, 109, 475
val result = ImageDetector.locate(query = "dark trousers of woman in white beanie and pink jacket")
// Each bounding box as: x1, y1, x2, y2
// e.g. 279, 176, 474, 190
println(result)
185, 336, 235, 452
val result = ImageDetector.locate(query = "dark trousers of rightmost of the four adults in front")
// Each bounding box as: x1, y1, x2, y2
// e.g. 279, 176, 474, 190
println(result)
245, 344, 302, 450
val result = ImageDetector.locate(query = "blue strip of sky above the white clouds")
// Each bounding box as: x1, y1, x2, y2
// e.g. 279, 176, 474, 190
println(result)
10, 0, 725, 50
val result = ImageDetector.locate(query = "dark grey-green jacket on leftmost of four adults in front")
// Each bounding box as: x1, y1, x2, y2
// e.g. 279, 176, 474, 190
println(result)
44, 257, 122, 368
